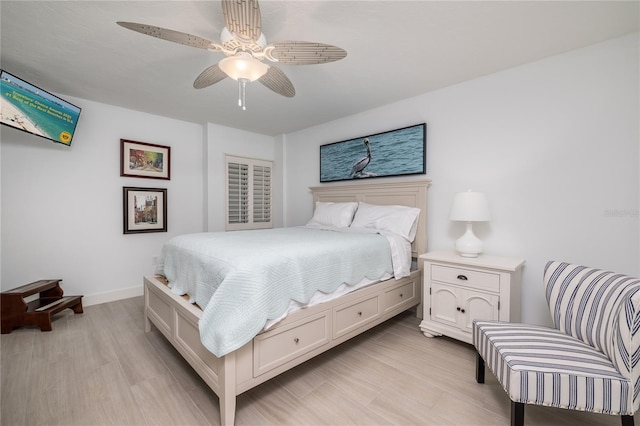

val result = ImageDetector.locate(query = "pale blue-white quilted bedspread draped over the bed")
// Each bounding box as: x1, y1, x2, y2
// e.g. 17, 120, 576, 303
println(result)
159, 227, 400, 357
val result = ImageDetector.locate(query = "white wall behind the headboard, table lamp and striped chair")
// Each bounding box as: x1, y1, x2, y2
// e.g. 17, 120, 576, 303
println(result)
284, 34, 640, 323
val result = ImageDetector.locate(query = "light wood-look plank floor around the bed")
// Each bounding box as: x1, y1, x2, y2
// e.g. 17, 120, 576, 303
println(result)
0, 297, 639, 426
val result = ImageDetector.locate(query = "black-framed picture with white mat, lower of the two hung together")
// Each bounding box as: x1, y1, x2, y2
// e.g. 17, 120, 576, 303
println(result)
122, 186, 167, 234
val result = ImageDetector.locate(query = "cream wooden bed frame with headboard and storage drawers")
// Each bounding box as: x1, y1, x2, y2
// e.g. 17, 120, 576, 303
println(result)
144, 179, 431, 425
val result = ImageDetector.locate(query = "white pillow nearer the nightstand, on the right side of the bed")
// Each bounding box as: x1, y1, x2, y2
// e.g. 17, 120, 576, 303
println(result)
351, 202, 420, 242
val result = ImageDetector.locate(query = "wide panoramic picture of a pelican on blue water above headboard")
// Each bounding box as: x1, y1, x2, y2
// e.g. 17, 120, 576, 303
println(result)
320, 123, 427, 182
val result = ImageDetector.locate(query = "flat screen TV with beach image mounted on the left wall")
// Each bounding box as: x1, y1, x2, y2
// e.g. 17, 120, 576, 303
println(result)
0, 70, 80, 146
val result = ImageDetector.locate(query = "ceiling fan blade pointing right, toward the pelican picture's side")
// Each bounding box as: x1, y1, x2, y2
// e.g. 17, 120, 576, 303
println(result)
270, 41, 347, 65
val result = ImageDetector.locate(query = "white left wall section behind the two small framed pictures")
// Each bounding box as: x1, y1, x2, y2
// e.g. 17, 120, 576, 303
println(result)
0, 97, 204, 305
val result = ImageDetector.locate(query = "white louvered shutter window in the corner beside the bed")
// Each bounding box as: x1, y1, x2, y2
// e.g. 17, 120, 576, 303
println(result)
225, 156, 273, 230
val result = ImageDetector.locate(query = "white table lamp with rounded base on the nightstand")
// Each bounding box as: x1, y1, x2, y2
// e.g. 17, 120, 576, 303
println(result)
449, 190, 491, 257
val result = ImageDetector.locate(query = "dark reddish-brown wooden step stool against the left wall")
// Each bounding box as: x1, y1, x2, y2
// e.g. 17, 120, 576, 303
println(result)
0, 280, 83, 334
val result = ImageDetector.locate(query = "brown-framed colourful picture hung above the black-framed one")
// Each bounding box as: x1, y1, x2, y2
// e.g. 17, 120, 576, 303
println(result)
120, 139, 171, 180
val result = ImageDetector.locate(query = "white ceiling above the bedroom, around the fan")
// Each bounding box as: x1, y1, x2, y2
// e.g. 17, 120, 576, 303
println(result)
0, 0, 640, 135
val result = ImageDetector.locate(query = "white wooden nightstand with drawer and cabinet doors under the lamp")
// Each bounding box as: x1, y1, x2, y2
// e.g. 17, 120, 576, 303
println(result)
418, 251, 525, 343
